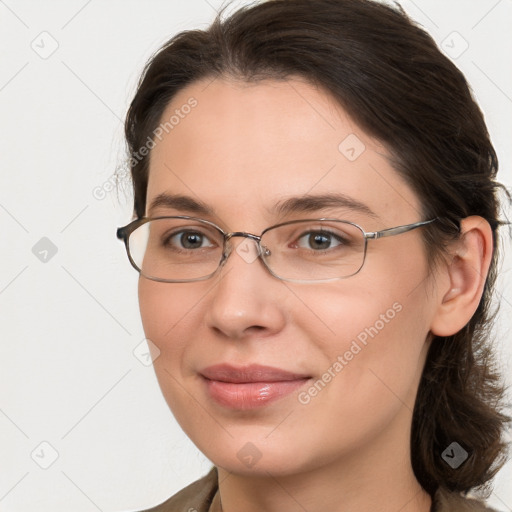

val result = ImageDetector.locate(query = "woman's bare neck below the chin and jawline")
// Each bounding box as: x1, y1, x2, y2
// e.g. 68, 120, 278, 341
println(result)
214, 414, 431, 512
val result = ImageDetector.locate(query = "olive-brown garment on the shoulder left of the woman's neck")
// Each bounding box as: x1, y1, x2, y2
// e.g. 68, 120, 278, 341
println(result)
136, 467, 218, 512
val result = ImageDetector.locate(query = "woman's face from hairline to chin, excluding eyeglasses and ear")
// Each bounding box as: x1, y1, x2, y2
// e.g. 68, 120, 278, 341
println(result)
139, 79, 437, 475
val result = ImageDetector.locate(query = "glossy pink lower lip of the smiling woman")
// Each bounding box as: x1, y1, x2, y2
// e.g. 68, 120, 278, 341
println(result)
205, 379, 309, 410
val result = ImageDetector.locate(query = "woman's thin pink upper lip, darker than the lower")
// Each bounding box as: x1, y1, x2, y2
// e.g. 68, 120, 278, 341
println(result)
199, 364, 309, 384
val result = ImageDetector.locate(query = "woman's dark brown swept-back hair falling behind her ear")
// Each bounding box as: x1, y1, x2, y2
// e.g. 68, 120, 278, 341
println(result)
125, 0, 510, 495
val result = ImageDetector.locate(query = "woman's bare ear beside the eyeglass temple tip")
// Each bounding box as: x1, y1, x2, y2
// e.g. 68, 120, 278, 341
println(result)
430, 215, 493, 336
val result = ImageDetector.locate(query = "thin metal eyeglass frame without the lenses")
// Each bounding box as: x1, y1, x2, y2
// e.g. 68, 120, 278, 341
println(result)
116, 215, 438, 283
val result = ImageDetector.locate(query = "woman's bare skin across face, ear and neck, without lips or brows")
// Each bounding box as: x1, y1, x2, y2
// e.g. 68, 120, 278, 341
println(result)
139, 78, 491, 512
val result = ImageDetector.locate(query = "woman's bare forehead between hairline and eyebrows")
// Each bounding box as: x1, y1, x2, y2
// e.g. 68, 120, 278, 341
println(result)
147, 78, 420, 226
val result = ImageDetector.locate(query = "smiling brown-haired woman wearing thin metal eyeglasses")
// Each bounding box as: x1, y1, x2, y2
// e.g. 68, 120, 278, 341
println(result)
118, 0, 508, 512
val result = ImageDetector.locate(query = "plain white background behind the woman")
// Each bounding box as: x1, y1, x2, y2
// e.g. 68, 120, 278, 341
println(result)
0, 0, 512, 512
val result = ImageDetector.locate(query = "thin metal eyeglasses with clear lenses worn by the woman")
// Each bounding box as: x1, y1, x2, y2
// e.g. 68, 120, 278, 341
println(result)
117, 216, 437, 283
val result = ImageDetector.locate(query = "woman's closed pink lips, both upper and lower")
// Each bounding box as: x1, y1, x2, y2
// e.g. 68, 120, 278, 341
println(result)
200, 364, 309, 410
